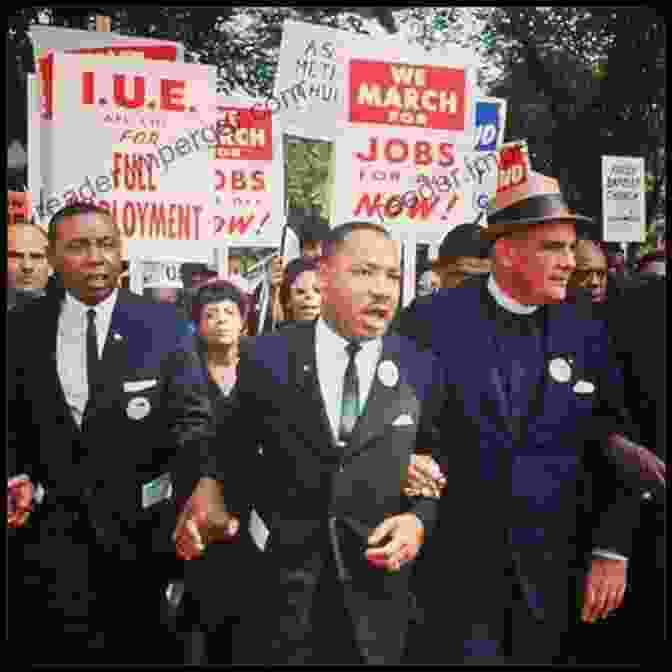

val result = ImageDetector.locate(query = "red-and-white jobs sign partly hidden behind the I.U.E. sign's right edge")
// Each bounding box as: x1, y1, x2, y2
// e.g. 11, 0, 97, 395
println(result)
206, 97, 285, 247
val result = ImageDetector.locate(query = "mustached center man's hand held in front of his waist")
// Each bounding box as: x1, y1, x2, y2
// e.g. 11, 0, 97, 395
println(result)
365, 513, 425, 572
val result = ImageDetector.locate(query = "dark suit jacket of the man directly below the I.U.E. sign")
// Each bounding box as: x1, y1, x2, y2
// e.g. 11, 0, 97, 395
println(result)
8, 289, 214, 608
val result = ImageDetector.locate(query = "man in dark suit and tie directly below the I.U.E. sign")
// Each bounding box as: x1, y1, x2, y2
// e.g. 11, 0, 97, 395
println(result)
8, 204, 213, 663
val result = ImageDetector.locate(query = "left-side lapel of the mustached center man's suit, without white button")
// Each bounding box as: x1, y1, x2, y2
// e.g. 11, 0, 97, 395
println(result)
289, 322, 338, 458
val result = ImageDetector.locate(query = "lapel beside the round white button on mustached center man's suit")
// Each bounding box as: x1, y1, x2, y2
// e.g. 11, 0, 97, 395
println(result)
344, 334, 410, 457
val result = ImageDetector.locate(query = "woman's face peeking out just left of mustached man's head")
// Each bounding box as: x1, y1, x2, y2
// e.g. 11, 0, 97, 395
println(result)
280, 258, 322, 325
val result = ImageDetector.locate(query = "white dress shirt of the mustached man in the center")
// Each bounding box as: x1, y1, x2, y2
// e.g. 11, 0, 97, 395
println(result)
315, 317, 383, 439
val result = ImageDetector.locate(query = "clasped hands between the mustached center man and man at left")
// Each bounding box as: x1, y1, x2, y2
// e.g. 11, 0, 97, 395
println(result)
173, 478, 240, 560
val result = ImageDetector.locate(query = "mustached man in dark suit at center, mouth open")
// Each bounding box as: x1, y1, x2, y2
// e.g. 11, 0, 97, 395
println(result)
177, 223, 443, 664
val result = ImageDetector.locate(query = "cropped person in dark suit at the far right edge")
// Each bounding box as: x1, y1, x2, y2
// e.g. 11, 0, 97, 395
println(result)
568, 277, 668, 665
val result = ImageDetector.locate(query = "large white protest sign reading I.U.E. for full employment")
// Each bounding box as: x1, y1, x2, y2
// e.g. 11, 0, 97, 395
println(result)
40, 53, 217, 253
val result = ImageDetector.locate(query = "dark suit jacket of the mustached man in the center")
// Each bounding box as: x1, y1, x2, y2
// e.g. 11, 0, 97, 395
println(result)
188, 323, 442, 663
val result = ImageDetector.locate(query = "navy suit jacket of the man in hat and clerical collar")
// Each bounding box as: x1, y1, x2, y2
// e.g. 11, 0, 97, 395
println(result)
402, 280, 638, 650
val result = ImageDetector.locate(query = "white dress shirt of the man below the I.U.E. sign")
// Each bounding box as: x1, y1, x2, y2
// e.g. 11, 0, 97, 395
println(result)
56, 289, 118, 427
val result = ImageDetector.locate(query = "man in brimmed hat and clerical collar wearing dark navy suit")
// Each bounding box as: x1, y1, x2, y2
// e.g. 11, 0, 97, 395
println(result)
400, 174, 638, 663
